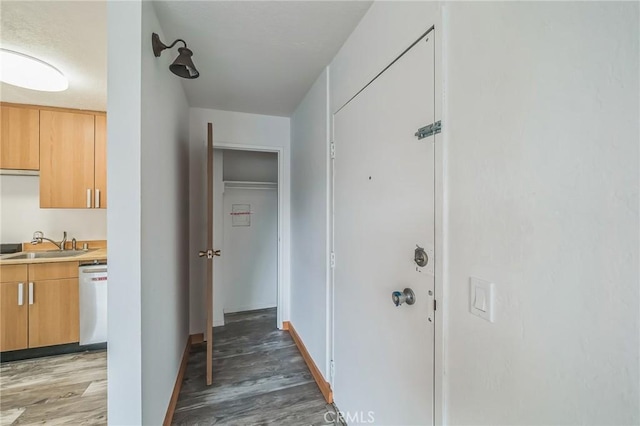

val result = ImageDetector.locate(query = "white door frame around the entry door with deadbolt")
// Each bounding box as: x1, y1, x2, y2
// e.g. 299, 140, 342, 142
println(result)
327, 24, 449, 425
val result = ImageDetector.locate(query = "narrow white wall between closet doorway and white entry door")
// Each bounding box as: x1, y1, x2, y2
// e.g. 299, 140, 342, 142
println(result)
291, 70, 330, 380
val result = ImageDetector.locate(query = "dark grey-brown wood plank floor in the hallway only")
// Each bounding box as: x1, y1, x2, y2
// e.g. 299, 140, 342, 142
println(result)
173, 309, 334, 425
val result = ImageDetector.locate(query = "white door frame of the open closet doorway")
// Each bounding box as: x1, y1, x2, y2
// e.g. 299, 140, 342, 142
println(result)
213, 141, 289, 330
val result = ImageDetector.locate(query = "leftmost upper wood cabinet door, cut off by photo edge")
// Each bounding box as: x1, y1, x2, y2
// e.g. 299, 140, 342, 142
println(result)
0, 105, 40, 170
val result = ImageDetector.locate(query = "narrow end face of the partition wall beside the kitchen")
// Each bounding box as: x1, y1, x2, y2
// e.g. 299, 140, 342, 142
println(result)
107, 1, 142, 425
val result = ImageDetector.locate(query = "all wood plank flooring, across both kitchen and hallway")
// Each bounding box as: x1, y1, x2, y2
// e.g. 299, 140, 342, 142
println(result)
0, 309, 335, 426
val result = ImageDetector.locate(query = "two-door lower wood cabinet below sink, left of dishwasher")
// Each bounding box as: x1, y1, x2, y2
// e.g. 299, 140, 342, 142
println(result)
0, 262, 80, 352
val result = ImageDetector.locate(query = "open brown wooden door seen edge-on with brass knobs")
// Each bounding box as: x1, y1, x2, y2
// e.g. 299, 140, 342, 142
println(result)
198, 123, 220, 385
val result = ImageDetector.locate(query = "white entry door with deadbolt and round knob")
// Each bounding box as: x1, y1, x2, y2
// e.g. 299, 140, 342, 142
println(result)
334, 33, 435, 425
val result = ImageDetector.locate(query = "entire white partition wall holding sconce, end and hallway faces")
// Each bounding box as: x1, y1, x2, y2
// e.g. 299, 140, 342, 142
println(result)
107, 2, 189, 425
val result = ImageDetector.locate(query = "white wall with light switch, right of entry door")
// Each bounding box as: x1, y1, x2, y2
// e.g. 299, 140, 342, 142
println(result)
444, 2, 640, 425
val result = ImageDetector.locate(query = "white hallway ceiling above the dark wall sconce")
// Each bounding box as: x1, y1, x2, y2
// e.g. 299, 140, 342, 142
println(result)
155, 0, 371, 116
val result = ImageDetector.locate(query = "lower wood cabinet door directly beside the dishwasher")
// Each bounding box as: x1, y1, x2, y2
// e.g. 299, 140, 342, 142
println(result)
29, 278, 80, 348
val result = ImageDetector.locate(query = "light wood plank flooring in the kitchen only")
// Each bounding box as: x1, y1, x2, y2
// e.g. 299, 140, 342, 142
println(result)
0, 351, 107, 426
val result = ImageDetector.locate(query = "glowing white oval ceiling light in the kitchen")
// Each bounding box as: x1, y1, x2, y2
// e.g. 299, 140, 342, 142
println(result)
0, 48, 69, 92
